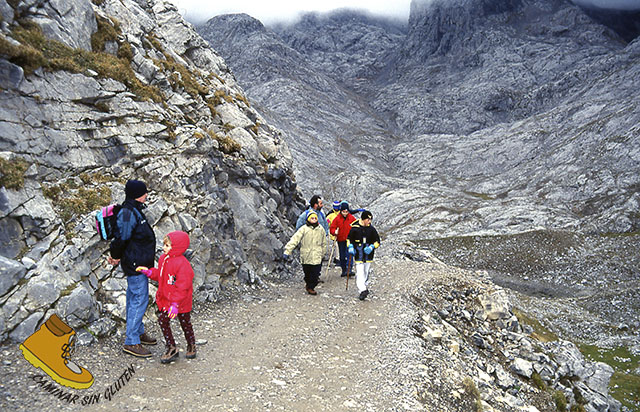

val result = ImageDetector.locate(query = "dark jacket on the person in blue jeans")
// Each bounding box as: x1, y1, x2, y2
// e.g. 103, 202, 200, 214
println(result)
109, 199, 156, 275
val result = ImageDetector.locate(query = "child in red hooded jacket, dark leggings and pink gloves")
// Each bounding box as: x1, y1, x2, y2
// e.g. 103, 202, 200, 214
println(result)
136, 231, 196, 363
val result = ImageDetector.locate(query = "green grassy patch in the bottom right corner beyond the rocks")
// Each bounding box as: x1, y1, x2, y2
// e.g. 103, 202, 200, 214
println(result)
580, 344, 640, 411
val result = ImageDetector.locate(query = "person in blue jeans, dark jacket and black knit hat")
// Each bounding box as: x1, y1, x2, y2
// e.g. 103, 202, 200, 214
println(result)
107, 180, 157, 358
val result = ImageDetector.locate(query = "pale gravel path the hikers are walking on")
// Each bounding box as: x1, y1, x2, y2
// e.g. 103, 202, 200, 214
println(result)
2, 257, 430, 411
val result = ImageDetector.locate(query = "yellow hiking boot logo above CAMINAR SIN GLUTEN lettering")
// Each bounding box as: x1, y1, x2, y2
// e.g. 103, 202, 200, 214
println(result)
20, 313, 93, 389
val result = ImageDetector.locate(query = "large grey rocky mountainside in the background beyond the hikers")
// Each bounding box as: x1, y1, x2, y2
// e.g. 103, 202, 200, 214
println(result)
198, 0, 638, 238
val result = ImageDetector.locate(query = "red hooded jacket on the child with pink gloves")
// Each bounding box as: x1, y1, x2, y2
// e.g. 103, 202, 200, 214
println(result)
149, 231, 193, 313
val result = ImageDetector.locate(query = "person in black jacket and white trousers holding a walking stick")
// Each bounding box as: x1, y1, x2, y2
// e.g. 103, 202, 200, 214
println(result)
347, 210, 380, 300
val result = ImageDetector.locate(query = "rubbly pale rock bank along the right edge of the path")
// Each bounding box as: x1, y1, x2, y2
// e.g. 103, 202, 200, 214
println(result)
394, 244, 621, 412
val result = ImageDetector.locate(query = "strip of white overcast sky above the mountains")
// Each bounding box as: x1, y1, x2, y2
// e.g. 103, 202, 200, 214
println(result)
169, 0, 411, 24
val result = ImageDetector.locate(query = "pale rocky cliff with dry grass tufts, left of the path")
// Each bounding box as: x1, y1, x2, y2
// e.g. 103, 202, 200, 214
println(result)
0, 0, 302, 341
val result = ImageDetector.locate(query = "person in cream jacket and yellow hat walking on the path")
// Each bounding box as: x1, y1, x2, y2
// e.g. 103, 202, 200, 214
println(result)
283, 210, 327, 295
